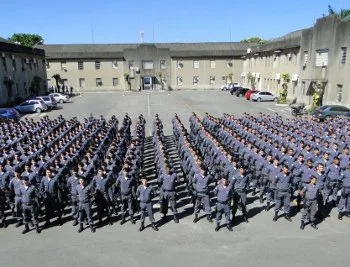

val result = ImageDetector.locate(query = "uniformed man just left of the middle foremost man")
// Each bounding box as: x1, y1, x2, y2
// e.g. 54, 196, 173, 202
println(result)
115, 169, 135, 225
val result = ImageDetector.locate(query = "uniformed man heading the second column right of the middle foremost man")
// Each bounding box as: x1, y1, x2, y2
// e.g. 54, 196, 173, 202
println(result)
192, 166, 213, 223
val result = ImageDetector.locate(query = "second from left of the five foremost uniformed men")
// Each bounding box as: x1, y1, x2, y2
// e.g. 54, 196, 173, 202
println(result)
75, 177, 95, 233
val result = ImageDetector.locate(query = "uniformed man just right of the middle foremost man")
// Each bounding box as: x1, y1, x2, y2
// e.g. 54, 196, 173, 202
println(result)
158, 166, 179, 223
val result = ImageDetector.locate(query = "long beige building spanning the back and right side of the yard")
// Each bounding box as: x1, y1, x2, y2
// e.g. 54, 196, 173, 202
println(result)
41, 15, 350, 105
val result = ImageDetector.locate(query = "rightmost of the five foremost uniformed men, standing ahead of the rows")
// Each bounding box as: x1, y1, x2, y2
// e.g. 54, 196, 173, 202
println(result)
300, 176, 320, 230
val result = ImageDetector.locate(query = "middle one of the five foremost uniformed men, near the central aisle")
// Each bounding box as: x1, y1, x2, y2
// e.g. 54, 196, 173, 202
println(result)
136, 179, 158, 232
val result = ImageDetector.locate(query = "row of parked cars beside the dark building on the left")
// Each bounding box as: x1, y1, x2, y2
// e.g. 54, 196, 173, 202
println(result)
0, 93, 69, 120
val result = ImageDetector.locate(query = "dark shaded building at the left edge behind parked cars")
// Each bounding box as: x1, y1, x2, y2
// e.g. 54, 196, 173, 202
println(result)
0, 38, 47, 106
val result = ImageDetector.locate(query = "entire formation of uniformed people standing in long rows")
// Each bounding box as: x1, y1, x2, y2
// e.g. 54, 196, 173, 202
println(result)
0, 113, 350, 234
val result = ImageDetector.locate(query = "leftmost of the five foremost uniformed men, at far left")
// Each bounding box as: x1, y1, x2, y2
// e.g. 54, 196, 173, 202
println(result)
20, 176, 40, 234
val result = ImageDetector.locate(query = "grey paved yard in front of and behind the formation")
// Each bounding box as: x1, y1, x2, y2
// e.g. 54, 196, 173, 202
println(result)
0, 91, 350, 267
